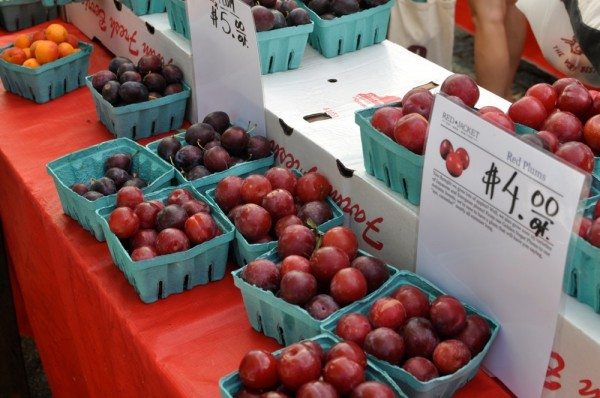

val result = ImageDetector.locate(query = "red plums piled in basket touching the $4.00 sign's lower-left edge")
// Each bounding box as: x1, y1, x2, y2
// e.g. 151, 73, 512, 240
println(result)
335, 285, 491, 381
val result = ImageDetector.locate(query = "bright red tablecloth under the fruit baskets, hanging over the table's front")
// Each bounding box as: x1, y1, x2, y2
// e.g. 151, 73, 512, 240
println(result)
0, 21, 509, 397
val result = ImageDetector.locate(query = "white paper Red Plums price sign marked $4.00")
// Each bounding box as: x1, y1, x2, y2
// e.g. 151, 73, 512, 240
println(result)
417, 95, 589, 397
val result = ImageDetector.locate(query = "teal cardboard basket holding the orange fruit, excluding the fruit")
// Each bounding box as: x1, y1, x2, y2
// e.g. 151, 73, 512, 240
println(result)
0, 42, 92, 104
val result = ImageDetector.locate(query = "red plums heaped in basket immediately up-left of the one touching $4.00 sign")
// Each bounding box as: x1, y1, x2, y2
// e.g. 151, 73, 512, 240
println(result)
242, 225, 389, 320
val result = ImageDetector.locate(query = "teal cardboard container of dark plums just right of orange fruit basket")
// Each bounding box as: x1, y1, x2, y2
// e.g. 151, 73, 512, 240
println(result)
85, 76, 190, 140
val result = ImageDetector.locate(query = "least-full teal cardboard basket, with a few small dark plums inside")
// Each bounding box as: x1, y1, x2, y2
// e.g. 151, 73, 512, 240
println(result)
46, 138, 175, 241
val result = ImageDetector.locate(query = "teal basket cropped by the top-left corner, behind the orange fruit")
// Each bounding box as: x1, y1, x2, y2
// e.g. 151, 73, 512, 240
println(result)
0, 0, 58, 32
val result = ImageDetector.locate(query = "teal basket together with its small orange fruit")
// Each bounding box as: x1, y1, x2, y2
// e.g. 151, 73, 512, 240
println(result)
0, 24, 92, 104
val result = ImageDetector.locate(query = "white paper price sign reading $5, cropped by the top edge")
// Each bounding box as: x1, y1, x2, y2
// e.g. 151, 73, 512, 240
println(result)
186, 0, 265, 135
